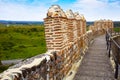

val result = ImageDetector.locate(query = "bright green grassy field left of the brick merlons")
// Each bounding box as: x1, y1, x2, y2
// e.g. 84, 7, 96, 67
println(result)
0, 25, 46, 60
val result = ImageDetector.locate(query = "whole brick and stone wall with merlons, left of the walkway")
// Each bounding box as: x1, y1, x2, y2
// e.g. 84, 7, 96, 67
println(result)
0, 5, 113, 80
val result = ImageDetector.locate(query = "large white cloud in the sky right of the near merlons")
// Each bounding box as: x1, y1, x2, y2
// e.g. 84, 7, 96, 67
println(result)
73, 0, 120, 21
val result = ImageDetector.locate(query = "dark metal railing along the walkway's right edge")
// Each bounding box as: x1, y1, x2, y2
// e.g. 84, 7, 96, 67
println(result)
106, 29, 120, 79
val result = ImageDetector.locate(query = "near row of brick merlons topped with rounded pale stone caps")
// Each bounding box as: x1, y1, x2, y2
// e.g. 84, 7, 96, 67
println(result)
44, 5, 86, 50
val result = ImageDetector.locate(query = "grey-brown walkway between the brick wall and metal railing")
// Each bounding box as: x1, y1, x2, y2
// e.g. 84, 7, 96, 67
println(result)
73, 36, 114, 80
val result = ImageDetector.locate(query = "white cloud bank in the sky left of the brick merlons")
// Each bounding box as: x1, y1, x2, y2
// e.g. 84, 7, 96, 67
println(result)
0, 0, 57, 21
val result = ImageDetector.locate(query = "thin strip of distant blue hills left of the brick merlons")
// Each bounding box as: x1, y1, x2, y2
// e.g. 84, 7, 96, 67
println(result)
0, 20, 43, 25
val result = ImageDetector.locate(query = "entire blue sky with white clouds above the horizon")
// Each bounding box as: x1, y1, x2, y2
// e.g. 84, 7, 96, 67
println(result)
0, 0, 120, 21
